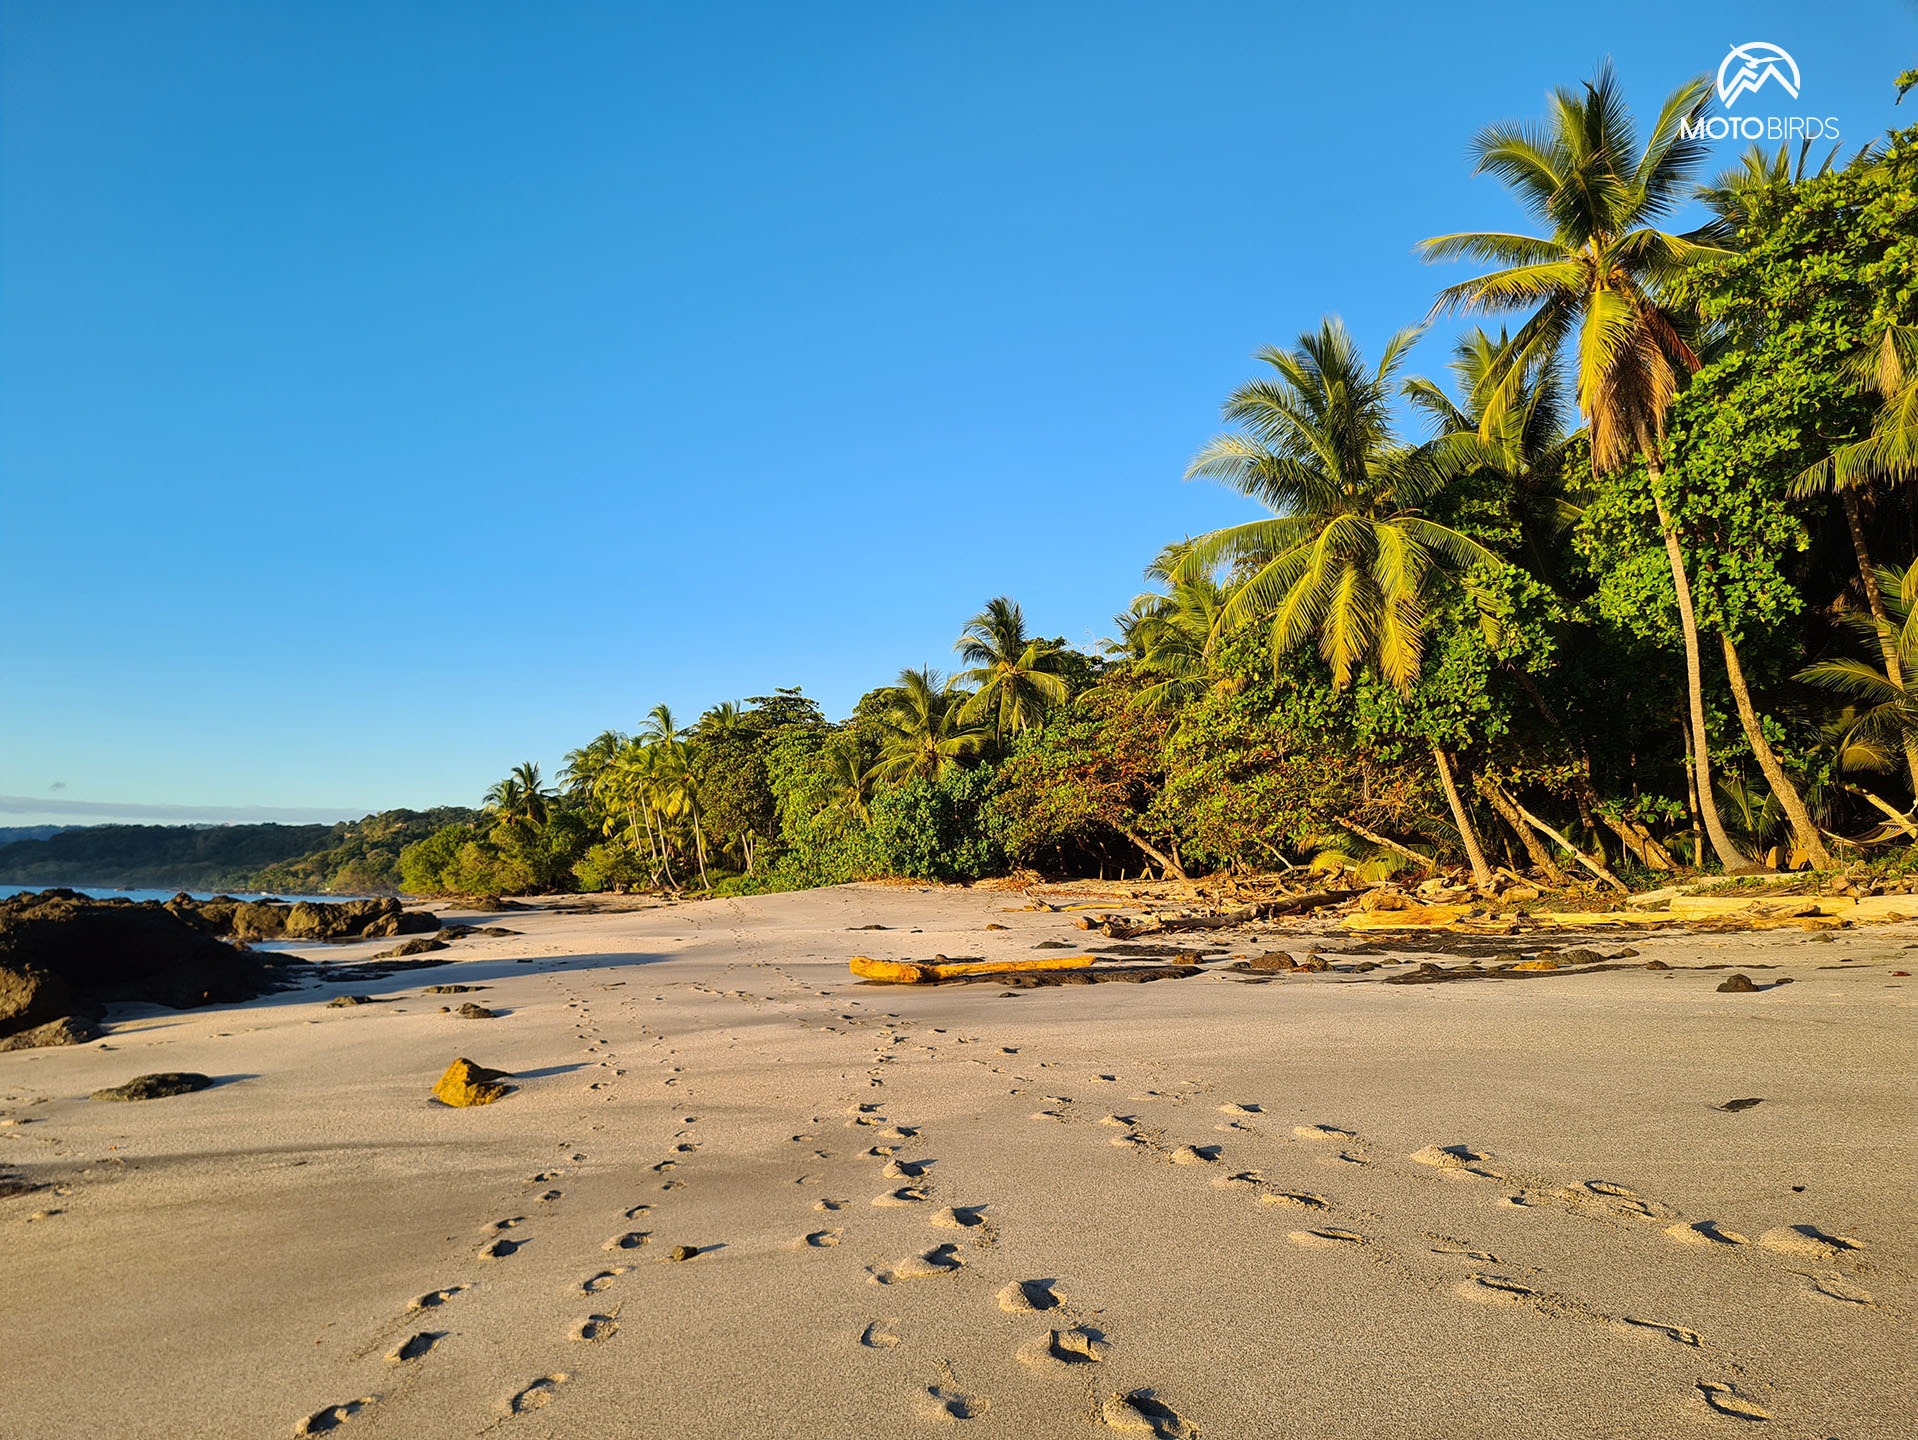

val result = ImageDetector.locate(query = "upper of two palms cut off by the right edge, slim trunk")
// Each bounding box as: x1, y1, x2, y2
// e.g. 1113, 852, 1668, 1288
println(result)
1791, 326, 1918, 796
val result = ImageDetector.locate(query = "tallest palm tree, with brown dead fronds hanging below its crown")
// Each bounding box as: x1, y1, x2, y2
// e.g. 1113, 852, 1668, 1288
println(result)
1419, 65, 1764, 869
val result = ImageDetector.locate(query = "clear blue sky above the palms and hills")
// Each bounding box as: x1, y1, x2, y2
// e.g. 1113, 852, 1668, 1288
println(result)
0, 0, 1918, 823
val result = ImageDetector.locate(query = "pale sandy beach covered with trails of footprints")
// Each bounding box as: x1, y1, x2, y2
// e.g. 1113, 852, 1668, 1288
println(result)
0, 886, 1918, 1440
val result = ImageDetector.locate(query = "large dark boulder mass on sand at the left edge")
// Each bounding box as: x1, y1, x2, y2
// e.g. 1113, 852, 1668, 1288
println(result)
0, 890, 274, 1049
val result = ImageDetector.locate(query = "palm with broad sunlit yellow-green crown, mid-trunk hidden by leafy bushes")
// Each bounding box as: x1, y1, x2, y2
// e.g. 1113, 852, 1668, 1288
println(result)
1176, 318, 1502, 890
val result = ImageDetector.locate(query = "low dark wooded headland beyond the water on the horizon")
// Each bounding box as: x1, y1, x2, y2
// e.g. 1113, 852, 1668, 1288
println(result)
0, 805, 472, 895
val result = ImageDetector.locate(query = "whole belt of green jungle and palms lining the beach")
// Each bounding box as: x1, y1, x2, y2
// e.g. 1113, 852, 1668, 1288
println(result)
401, 69, 1918, 892
